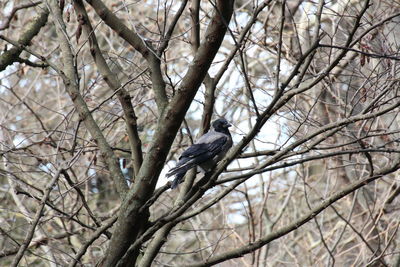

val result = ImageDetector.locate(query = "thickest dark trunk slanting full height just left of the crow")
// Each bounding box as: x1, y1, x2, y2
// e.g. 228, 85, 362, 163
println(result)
105, 0, 233, 266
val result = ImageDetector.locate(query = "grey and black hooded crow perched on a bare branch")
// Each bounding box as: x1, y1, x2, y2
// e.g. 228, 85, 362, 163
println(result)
166, 118, 233, 189
